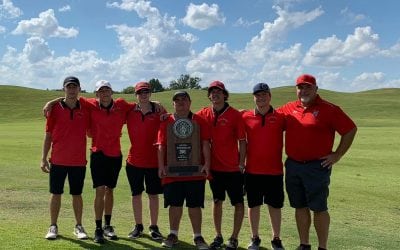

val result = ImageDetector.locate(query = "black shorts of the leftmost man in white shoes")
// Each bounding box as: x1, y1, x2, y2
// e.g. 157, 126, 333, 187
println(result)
49, 164, 86, 195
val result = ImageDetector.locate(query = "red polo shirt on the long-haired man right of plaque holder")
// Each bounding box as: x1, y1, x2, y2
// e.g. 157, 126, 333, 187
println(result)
197, 106, 246, 172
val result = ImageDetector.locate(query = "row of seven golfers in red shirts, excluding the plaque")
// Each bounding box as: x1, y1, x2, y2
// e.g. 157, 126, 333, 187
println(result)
41, 74, 357, 250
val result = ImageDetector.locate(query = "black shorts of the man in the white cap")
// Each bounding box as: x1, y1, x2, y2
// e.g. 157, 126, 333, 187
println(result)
90, 151, 122, 188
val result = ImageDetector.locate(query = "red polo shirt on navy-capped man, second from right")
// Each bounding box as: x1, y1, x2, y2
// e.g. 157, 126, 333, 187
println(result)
242, 107, 285, 175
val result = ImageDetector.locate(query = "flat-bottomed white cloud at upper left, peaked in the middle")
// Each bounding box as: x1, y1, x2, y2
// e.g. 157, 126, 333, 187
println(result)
12, 9, 78, 38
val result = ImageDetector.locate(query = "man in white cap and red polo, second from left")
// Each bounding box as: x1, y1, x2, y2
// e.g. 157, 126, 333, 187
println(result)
86, 80, 134, 243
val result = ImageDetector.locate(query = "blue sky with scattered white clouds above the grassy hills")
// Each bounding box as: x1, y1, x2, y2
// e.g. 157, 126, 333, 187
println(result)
0, 0, 400, 92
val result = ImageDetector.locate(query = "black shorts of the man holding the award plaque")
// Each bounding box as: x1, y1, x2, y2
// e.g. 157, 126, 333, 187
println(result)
164, 180, 206, 208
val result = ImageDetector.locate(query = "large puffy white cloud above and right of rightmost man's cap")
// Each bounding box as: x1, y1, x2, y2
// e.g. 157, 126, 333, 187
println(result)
304, 26, 379, 67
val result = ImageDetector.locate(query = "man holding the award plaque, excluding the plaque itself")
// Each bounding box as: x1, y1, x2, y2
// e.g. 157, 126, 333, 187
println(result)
157, 91, 210, 250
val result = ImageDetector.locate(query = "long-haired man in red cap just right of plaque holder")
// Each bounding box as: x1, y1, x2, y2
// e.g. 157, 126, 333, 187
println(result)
197, 81, 246, 249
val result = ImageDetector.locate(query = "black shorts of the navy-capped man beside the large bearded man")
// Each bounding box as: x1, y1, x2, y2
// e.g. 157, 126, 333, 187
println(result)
245, 174, 285, 208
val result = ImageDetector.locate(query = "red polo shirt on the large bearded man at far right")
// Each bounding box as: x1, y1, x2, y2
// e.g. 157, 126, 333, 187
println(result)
279, 95, 356, 161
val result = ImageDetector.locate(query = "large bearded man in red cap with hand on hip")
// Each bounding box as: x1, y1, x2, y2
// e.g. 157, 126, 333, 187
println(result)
280, 74, 357, 250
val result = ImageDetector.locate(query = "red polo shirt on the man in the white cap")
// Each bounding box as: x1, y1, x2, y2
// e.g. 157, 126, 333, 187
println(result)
81, 98, 134, 157
